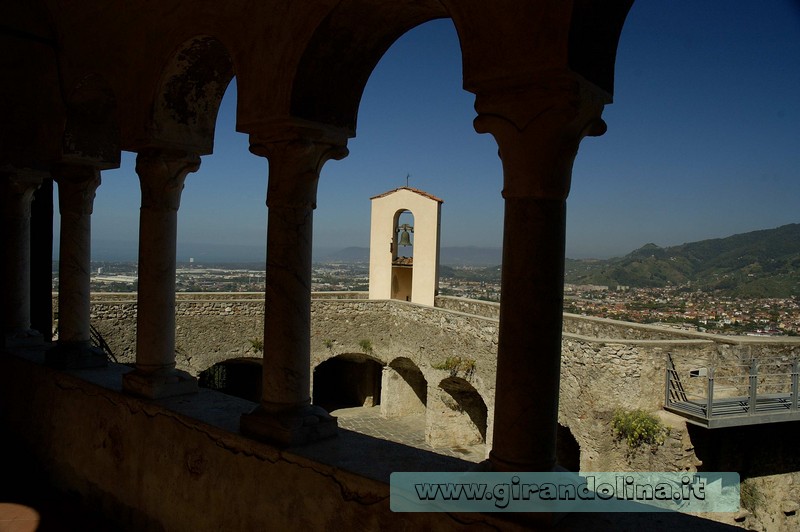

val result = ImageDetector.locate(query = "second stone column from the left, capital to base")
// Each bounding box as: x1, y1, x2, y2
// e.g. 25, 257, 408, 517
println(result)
46, 164, 106, 369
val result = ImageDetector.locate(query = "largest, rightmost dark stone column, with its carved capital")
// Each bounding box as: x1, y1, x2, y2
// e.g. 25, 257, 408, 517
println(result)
475, 73, 605, 471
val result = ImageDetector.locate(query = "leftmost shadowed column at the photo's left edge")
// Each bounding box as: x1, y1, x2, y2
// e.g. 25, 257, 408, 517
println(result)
0, 170, 45, 347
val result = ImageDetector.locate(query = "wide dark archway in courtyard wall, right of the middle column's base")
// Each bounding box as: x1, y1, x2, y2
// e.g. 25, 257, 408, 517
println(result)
312, 353, 383, 412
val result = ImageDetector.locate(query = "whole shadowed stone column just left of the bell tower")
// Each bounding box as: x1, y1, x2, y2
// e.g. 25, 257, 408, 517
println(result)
241, 123, 347, 445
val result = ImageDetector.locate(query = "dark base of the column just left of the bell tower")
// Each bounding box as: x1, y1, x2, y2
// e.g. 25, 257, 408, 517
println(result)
239, 405, 339, 447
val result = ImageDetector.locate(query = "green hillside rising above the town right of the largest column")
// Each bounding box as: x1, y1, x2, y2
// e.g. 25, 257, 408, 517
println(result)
565, 224, 800, 297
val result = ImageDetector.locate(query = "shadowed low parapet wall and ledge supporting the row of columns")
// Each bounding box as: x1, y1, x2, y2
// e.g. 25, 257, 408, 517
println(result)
0, 350, 536, 532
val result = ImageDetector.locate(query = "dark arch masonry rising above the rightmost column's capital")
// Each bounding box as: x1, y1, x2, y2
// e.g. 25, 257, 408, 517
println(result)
441, 0, 633, 94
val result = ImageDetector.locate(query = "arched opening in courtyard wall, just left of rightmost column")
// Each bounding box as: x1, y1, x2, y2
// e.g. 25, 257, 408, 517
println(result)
425, 377, 488, 448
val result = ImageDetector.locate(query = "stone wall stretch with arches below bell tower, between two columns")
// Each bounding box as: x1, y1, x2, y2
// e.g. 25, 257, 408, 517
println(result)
311, 300, 497, 454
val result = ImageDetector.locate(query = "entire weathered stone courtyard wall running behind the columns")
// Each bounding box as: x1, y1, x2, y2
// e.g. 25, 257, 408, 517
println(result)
57, 293, 800, 529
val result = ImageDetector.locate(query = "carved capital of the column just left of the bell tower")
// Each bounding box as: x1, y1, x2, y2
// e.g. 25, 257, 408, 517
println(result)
250, 119, 349, 209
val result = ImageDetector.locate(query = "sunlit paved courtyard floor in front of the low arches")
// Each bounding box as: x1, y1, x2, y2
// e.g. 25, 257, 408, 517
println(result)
331, 407, 486, 463
